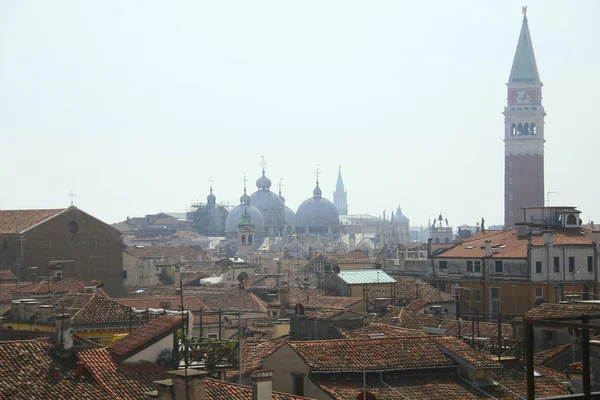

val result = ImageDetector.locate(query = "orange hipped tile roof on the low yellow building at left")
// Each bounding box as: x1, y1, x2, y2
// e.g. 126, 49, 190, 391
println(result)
71, 293, 131, 325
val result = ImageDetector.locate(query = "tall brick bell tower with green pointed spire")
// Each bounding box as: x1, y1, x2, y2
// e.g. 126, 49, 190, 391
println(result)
504, 7, 546, 229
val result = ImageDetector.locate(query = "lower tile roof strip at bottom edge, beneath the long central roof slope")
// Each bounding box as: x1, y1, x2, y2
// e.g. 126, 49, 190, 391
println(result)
311, 372, 496, 400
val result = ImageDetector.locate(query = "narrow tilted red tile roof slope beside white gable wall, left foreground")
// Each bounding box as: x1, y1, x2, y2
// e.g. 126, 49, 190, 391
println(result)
108, 315, 181, 358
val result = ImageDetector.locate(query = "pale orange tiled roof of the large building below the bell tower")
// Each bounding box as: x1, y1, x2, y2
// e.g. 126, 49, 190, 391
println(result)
434, 228, 593, 258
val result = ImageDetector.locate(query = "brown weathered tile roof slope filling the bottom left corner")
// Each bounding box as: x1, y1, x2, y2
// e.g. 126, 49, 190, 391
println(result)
0, 340, 114, 400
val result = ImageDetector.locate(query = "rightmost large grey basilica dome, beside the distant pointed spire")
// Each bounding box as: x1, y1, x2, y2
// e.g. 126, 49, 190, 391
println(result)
296, 181, 340, 235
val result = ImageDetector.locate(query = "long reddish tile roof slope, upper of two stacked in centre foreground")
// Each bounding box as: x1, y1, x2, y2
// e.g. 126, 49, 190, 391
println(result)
289, 337, 455, 372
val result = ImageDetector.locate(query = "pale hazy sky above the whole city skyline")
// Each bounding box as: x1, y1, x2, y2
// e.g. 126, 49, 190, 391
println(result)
0, 0, 600, 226
